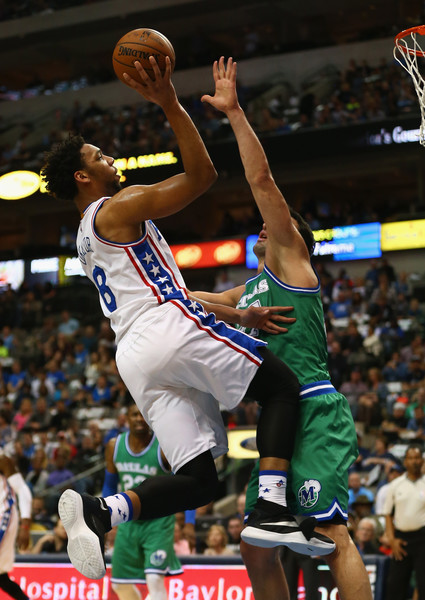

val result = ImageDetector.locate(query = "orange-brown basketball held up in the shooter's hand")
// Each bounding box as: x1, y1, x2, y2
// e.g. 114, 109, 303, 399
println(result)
112, 28, 176, 85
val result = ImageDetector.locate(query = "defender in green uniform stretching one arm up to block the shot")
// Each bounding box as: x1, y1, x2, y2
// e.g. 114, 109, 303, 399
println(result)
194, 57, 372, 600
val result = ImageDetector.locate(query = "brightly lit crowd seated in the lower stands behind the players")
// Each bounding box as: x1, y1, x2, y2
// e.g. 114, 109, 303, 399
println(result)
0, 251, 425, 554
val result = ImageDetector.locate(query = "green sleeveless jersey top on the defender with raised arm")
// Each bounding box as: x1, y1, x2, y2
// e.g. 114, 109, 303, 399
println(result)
237, 266, 329, 385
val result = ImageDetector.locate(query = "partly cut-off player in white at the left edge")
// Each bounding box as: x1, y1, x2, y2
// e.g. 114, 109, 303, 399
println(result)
0, 454, 32, 600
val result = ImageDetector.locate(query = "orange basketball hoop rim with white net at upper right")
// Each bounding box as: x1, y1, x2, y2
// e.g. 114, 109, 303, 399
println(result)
393, 25, 425, 146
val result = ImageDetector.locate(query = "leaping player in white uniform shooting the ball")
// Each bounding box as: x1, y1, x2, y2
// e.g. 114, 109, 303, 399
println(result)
43, 57, 334, 579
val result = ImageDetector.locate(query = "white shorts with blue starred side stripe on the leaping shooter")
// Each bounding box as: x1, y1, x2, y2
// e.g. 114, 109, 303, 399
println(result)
116, 300, 265, 472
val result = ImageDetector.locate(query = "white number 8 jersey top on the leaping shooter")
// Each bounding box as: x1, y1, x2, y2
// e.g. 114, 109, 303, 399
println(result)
77, 198, 188, 343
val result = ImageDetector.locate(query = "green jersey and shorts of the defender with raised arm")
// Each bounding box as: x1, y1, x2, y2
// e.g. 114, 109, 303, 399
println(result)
238, 267, 357, 522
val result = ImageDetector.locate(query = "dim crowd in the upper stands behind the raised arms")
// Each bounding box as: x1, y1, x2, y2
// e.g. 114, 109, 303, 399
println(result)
0, 54, 419, 237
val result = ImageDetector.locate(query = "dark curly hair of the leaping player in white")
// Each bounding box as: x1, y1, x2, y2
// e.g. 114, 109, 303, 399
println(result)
41, 135, 85, 200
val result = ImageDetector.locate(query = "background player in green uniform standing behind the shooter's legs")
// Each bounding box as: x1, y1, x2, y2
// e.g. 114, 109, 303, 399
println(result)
102, 404, 183, 600
